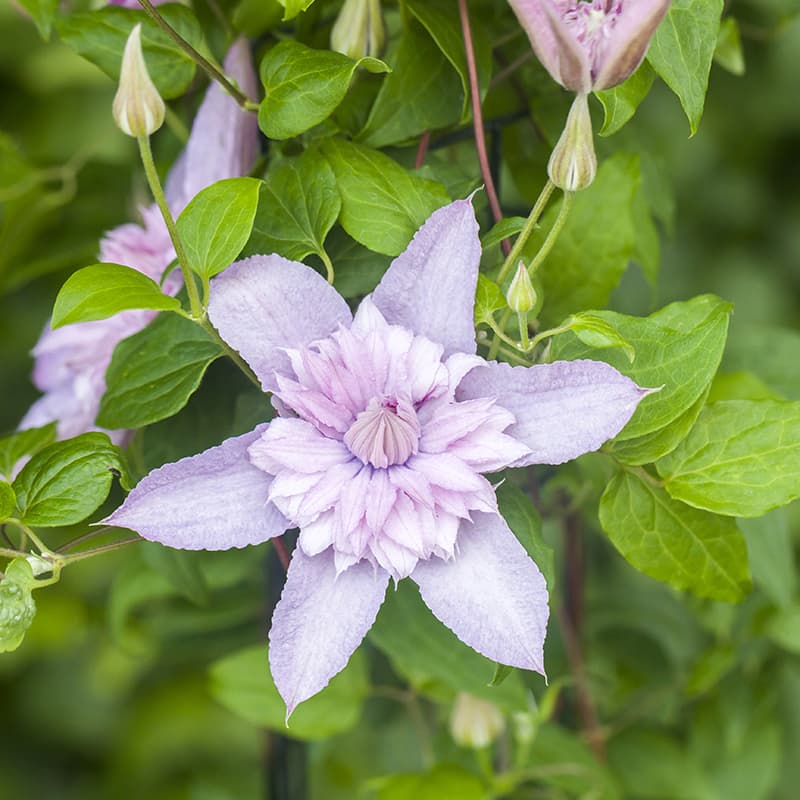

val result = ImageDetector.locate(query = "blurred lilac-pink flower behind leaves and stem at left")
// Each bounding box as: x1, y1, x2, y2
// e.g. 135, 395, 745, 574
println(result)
20, 39, 258, 443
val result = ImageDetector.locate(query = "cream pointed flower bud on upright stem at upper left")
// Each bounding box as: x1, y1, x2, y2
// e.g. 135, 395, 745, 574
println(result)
112, 24, 166, 138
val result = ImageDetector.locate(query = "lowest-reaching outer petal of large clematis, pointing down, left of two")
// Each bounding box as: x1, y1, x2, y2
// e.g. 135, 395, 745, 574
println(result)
269, 549, 389, 719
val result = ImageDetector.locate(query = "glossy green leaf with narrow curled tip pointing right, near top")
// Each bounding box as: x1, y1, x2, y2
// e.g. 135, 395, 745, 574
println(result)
258, 40, 389, 139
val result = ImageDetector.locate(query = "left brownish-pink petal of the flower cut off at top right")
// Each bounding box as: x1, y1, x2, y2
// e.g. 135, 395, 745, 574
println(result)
509, 0, 591, 92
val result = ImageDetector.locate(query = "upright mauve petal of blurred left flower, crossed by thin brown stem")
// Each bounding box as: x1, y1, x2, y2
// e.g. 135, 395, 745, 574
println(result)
167, 38, 258, 215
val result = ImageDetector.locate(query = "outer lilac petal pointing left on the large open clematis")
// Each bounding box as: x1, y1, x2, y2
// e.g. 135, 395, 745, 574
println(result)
104, 425, 289, 550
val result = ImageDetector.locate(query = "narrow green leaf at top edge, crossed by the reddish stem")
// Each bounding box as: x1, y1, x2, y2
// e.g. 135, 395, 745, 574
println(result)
406, 0, 492, 122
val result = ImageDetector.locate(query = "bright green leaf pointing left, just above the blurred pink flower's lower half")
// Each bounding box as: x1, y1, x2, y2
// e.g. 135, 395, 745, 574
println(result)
50, 264, 181, 329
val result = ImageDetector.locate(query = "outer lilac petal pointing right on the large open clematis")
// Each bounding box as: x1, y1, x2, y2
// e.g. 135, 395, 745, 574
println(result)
456, 361, 648, 467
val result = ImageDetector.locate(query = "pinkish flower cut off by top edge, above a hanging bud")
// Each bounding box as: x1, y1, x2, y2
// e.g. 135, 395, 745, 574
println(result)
509, 0, 669, 94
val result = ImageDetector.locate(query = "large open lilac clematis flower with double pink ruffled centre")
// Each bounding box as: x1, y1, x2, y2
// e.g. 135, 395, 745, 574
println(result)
105, 200, 646, 714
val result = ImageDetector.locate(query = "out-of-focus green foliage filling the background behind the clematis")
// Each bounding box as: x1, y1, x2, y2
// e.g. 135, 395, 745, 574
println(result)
0, 0, 800, 800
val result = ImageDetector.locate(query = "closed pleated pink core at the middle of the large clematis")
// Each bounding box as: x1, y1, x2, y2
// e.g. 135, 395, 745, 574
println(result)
344, 397, 420, 468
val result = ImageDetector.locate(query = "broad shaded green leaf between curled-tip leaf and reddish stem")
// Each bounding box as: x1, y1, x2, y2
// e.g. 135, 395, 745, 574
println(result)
358, 20, 463, 148
